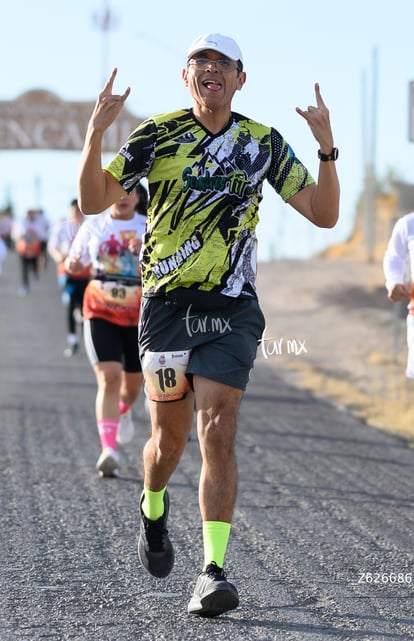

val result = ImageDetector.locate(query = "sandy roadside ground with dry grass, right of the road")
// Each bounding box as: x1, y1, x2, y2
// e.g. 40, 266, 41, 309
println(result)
258, 252, 414, 446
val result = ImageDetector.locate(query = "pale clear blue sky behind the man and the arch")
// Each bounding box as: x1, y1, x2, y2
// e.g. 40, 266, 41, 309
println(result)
0, 0, 414, 259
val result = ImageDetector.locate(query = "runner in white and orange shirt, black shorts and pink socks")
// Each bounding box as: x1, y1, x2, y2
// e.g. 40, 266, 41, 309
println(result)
65, 185, 148, 476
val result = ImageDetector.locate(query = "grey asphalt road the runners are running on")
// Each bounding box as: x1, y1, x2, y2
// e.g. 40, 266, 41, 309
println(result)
0, 255, 414, 641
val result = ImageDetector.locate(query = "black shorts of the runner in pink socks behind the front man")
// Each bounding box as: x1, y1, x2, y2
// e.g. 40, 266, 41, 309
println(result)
83, 318, 141, 373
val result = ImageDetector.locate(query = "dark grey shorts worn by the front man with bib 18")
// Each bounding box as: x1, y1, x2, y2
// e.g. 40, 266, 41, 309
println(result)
138, 296, 265, 390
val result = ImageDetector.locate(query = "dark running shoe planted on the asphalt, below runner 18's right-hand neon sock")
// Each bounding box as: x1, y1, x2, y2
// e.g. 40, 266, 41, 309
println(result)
188, 563, 239, 617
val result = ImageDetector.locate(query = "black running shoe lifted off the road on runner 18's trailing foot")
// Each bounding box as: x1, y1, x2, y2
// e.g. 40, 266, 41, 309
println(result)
138, 491, 174, 579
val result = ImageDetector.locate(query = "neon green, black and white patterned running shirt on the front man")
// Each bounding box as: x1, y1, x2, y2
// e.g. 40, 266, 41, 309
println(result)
105, 109, 314, 297
